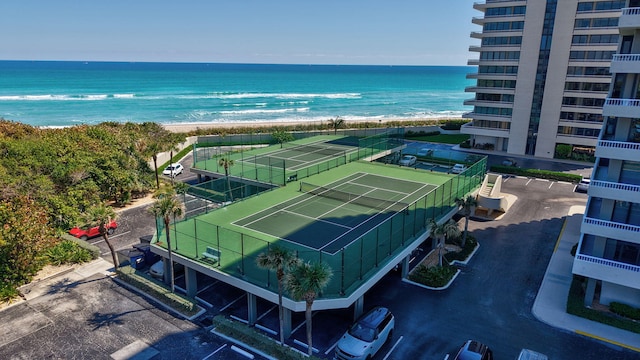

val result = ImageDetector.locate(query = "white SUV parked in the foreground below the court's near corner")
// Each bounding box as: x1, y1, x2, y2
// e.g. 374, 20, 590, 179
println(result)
334, 306, 395, 360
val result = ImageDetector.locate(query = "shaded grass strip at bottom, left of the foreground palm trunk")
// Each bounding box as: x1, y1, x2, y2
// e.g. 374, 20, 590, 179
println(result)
213, 315, 318, 360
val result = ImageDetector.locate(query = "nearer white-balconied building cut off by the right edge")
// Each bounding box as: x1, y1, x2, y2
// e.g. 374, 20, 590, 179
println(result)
573, 0, 640, 307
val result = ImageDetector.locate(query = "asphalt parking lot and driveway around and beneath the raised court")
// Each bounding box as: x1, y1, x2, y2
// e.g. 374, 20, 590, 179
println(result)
6, 152, 637, 360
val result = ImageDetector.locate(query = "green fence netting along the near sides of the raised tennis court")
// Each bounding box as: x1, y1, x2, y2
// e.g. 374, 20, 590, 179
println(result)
155, 157, 487, 299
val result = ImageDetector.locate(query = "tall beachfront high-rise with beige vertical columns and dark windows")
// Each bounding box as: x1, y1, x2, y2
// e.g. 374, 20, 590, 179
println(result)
462, 0, 626, 158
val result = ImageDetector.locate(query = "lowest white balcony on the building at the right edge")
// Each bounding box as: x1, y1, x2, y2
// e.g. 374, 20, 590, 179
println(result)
573, 254, 640, 289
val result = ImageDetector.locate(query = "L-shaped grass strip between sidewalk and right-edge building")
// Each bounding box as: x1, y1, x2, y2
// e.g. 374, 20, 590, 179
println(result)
567, 276, 640, 334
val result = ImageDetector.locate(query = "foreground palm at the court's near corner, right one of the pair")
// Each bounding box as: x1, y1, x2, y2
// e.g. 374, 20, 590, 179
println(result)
285, 262, 333, 356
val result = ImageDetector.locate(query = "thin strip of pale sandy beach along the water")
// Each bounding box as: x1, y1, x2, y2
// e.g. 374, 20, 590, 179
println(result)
160, 116, 464, 133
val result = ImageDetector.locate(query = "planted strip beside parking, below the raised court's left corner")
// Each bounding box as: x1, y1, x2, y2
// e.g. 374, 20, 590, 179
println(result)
116, 266, 200, 317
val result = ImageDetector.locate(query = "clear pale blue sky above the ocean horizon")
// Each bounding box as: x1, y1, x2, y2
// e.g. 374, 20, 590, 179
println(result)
0, 0, 481, 65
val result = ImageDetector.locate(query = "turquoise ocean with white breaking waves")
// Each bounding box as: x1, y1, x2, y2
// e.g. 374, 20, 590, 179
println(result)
0, 61, 475, 126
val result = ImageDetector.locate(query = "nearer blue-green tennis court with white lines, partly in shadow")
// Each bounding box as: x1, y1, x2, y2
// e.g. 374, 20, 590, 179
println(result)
234, 172, 436, 254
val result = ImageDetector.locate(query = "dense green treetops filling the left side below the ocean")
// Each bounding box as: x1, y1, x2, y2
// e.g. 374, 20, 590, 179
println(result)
0, 119, 184, 300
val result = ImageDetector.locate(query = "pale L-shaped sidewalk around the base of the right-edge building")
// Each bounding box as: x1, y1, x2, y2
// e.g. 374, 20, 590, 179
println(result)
532, 207, 640, 352
